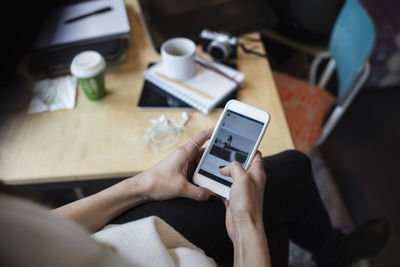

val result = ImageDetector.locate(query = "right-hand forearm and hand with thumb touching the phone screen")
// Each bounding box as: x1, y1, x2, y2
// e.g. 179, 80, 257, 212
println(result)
220, 151, 271, 267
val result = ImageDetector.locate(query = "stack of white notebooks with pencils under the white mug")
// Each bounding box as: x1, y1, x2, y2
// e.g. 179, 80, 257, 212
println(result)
142, 56, 245, 114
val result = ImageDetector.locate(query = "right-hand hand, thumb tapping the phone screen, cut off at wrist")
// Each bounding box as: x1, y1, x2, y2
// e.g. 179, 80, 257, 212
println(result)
220, 151, 267, 243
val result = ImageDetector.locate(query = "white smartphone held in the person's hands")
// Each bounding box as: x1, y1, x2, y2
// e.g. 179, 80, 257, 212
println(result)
193, 100, 270, 199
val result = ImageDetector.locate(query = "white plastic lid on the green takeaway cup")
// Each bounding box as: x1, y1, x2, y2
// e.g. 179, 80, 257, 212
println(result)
71, 50, 106, 78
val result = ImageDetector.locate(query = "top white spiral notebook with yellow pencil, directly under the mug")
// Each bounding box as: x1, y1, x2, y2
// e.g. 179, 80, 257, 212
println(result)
144, 58, 244, 114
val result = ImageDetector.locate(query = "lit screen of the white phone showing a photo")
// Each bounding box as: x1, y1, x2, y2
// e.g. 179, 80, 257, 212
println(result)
199, 110, 264, 187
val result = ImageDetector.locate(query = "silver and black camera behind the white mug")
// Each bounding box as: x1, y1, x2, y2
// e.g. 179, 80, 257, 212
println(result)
200, 29, 238, 61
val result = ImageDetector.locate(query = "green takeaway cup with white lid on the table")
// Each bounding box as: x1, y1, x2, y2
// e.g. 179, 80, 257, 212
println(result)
71, 50, 106, 100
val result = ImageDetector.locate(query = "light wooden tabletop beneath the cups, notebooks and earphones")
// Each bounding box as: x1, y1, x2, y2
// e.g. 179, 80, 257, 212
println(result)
0, 0, 293, 185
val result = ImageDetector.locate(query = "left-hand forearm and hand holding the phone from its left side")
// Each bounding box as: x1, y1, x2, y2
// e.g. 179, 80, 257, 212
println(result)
53, 129, 213, 233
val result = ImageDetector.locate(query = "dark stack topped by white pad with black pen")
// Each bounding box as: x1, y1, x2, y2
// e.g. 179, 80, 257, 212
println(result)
28, 0, 130, 75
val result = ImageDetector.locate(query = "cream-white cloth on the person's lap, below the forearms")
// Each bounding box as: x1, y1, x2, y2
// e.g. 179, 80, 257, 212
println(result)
93, 217, 216, 267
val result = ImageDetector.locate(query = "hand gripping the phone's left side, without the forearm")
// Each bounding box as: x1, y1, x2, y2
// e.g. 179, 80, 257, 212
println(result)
134, 129, 214, 201
